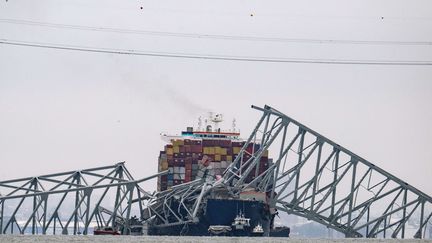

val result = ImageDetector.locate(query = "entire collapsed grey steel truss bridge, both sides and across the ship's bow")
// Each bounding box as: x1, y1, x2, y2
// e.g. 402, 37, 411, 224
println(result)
0, 106, 432, 238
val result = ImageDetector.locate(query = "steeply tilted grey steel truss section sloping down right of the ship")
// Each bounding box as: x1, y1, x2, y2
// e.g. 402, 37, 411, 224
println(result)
224, 106, 432, 238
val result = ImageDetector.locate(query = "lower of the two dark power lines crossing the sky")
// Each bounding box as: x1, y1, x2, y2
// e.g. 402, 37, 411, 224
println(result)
0, 39, 432, 66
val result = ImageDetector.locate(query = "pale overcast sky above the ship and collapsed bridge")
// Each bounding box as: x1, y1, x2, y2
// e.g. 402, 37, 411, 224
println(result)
0, 0, 432, 195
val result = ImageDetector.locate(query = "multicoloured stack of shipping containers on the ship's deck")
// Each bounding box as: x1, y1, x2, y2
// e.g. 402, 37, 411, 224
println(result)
157, 139, 269, 191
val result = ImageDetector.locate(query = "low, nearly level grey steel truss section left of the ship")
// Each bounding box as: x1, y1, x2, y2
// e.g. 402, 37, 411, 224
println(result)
0, 162, 164, 234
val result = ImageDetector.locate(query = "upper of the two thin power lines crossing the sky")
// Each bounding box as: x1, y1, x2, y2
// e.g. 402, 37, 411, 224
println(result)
0, 19, 432, 46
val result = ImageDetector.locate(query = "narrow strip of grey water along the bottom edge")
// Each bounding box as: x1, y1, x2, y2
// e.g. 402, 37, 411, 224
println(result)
0, 235, 432, 243
